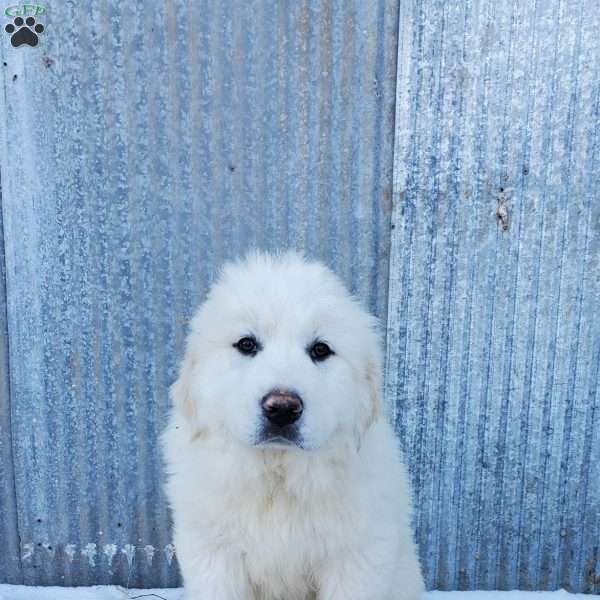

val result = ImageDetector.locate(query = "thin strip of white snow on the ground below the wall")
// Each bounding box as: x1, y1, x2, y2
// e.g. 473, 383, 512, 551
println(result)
0, 584, 590, 600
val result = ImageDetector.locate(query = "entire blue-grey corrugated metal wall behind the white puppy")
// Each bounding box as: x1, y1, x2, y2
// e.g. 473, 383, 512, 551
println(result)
0, 0, 600, 592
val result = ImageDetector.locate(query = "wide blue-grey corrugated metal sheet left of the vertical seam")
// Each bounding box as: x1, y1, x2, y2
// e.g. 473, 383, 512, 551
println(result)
0, 0, 398, 586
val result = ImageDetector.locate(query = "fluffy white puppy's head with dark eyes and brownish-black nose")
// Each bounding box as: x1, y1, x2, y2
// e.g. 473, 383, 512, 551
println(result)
171, 254, 381, 450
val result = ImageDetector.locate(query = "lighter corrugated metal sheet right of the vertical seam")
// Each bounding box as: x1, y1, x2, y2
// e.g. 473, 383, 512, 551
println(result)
387, 0, 600, 593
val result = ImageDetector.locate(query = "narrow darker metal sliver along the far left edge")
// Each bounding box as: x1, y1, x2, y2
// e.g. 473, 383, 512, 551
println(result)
0, 179, 22, 583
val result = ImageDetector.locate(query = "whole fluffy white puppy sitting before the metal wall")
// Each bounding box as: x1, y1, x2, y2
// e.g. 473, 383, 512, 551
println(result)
163, 254, 423, 600
